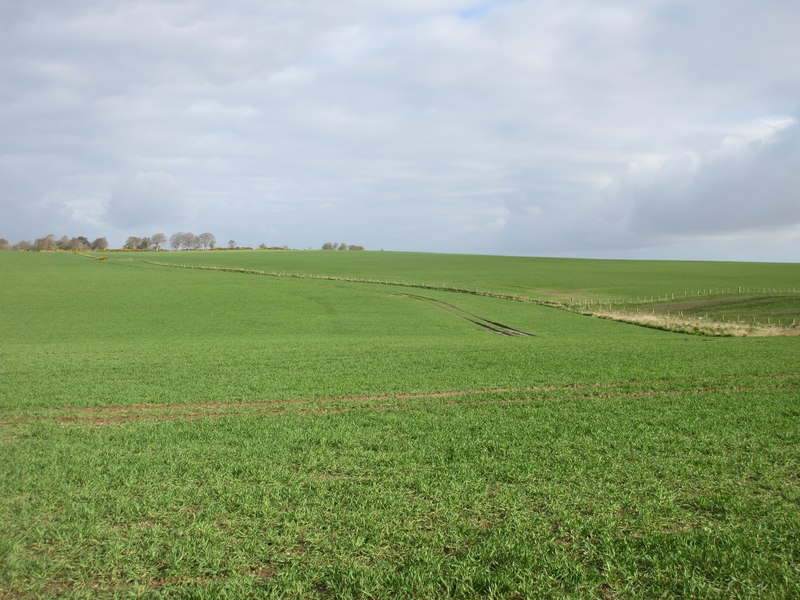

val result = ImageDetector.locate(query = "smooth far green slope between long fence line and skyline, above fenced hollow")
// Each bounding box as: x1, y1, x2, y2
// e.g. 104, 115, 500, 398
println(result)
120, 251, 800, 299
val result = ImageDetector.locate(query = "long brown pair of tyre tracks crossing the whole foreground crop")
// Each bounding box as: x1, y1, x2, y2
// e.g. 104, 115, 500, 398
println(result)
0, 373, 800, 426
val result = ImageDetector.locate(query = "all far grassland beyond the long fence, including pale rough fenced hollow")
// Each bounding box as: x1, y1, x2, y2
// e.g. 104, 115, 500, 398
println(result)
122, 252, 800, 335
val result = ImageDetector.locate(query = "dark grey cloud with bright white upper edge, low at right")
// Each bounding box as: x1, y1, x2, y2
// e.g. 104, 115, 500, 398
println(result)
621, 120, 800, 236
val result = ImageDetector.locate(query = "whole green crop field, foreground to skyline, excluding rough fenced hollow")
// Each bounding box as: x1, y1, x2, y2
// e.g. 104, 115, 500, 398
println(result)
0, 251, 800, 598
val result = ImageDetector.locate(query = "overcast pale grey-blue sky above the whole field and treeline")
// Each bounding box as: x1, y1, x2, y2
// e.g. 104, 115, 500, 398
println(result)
0, 0, 800, 262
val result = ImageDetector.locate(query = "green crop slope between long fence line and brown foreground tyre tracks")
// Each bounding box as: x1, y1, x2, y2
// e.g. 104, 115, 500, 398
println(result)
0, 254, 800, 406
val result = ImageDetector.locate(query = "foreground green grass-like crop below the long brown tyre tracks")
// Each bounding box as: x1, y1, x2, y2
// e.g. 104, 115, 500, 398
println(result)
3, 389, 800, 597
